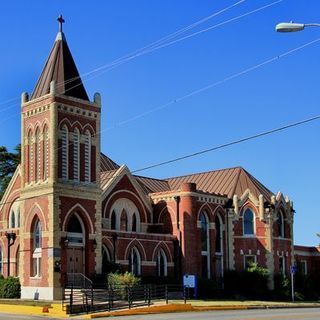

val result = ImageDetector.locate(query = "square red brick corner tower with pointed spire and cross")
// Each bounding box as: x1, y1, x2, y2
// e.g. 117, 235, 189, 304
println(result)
20, 16, 101, 299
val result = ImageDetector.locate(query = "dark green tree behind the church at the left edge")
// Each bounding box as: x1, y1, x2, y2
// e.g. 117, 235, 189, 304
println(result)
0, 144, 21, 200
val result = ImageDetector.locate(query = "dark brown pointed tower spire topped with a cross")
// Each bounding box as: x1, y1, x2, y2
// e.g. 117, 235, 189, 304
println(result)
31, 15, 89, 101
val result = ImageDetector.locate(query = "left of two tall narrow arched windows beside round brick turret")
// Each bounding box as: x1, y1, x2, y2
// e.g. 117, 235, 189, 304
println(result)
200, 212, 210, 278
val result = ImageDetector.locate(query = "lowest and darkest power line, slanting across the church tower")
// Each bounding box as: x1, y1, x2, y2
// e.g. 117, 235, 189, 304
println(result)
0, 115, 320, 206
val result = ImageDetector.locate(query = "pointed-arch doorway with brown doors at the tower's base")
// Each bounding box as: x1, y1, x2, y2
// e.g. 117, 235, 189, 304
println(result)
66, 214, 85, 274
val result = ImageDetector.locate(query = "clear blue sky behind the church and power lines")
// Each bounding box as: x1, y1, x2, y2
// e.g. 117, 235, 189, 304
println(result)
0, 0, 320, 245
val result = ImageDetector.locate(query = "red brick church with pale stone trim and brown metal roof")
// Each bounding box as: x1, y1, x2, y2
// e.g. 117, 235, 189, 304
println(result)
0, 20, 319, 300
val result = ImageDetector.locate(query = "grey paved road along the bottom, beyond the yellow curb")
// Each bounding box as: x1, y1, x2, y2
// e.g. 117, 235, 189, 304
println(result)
0, 308, 320, 320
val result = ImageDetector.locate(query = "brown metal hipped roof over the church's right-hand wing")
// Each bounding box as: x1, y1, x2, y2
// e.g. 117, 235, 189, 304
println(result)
167, 167, 273, 200
